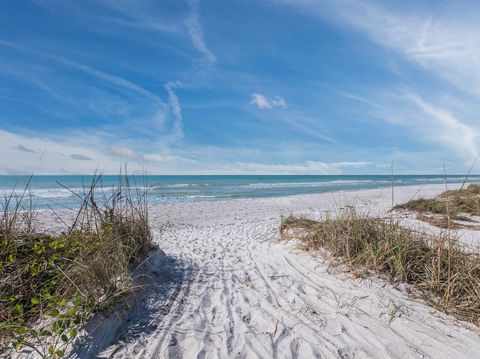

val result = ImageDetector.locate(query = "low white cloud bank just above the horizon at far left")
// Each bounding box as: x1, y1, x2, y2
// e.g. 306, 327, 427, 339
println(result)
0, 130, 198, 174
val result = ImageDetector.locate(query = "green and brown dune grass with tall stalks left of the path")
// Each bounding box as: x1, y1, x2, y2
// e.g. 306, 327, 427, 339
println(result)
0, 176, 153, 358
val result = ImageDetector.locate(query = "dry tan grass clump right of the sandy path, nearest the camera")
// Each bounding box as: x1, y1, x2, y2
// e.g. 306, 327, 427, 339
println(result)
280, 207, 480, 325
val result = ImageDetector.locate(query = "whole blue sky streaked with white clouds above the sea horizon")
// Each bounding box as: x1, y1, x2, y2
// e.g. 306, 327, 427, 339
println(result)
0, 0, 480, 175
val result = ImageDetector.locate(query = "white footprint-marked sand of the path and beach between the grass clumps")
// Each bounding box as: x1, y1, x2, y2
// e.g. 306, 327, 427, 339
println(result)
54, 185, 480, 359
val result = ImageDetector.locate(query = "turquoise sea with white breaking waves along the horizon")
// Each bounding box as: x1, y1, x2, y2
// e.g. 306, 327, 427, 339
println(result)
0, 175, 480, 209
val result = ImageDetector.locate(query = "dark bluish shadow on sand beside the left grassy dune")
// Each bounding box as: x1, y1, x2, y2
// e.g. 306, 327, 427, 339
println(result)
69, 250, 196, 359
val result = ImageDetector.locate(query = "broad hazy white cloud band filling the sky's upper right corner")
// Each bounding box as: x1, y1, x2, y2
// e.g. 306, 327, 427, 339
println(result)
272, 0, 480, 96
